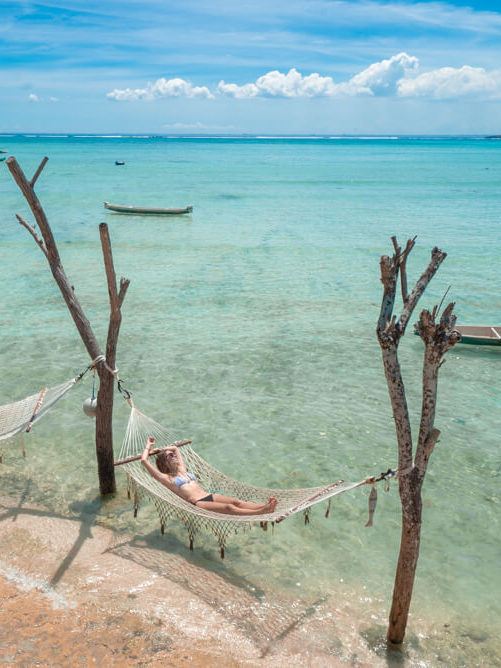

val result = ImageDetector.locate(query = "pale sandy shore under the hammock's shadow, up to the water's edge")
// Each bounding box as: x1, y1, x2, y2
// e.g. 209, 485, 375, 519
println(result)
0, 498, 360, 668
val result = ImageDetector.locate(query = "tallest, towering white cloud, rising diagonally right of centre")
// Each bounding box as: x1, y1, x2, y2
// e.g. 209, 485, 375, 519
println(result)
336, 53, 419, 95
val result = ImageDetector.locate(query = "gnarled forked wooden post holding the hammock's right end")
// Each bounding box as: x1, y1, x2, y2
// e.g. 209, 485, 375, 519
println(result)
377, 237, 460, 644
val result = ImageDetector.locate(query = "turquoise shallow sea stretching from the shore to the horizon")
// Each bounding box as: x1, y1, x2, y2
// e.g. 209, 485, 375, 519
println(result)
0, 136, 501, 666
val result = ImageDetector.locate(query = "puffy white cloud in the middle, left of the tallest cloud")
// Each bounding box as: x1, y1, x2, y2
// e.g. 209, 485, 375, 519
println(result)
217, 67, 335, 98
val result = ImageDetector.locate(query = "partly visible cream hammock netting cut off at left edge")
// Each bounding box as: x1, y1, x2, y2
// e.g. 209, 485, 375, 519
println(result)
0, 378, 79, 441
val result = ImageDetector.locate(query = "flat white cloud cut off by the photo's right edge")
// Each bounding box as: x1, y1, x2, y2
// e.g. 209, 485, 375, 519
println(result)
398, 65, 501, 99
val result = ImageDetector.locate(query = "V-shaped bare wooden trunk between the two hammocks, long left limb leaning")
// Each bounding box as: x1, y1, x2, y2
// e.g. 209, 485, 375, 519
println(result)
6, 157, 129, 494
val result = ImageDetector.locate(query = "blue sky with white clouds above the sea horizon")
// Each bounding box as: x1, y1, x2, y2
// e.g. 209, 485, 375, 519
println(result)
0, 0, 501, 134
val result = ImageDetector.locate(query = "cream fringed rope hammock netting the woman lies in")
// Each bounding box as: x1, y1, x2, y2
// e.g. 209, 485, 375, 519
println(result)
120, 407, 367, 556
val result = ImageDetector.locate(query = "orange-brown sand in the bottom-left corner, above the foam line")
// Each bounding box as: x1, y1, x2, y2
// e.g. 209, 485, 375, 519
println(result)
0, 579, 223, 668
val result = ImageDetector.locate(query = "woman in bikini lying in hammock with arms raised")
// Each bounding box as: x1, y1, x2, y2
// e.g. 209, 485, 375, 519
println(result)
141, 436, 277, 515
